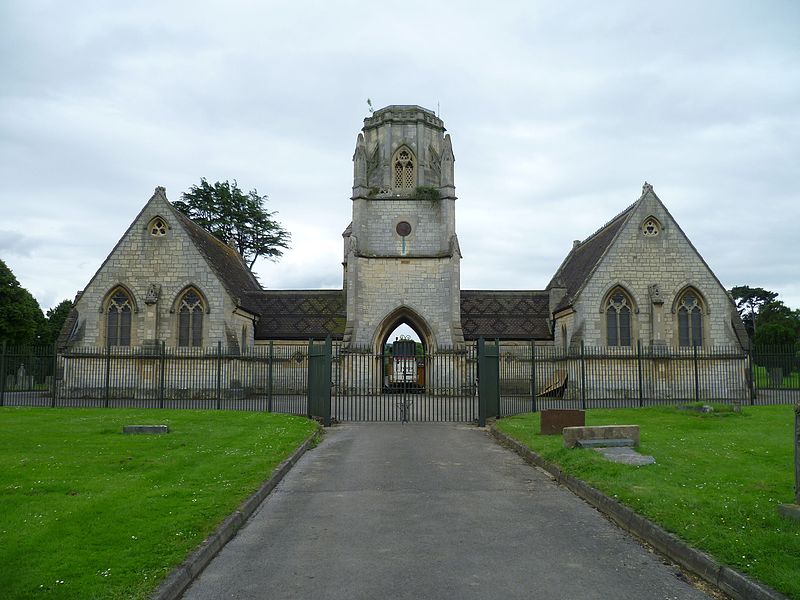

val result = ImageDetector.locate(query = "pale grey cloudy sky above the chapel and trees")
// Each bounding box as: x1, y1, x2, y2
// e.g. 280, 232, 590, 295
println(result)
0, 0, 800, 309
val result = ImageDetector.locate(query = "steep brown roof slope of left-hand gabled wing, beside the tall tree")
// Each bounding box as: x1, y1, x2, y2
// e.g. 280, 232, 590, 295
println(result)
170, 204, 261, 312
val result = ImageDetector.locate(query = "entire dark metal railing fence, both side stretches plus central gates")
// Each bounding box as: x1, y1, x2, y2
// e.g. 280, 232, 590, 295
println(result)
0, 342, 800, 421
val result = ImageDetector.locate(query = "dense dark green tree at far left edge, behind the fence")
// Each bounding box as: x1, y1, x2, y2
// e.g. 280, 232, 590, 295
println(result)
0, 260, 47, 346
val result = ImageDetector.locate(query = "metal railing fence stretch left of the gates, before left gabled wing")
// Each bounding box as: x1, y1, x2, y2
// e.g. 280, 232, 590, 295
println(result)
0, 343, 308, 414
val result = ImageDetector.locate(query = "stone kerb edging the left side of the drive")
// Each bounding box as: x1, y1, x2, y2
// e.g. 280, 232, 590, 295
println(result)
150, 427, 322, 600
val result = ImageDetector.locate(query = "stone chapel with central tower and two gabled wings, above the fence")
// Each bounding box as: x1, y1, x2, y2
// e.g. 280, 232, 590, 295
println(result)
60, 105, 747, 353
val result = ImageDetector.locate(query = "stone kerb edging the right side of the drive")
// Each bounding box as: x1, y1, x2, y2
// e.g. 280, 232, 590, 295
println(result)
489, 423, 789, 600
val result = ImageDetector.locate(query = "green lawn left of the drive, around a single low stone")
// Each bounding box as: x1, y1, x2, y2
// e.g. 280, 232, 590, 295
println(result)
0, 408, 316, 598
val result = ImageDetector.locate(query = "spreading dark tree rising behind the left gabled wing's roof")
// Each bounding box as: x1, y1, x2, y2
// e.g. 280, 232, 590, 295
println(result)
173, 178, 291, 269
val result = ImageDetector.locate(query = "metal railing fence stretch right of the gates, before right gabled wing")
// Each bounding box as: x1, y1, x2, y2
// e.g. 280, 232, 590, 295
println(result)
500, 342, 800, 415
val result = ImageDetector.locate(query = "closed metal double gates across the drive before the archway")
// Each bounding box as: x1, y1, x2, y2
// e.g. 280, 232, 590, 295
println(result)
331, 344, 478, 422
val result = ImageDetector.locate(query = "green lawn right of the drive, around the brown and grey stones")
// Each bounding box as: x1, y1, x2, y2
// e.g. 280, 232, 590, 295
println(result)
497, 406, 800, 599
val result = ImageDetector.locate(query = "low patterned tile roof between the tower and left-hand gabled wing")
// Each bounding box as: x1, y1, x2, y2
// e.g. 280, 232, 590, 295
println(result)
245, 290, 347, 340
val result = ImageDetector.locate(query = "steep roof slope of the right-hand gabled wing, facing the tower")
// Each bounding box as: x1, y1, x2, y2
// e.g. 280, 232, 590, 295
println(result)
547, 203, 636, 312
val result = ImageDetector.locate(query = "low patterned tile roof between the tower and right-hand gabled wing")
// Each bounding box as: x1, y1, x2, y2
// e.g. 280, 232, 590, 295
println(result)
461, 290, 553, 340
